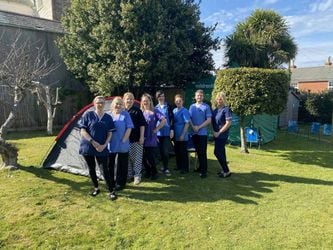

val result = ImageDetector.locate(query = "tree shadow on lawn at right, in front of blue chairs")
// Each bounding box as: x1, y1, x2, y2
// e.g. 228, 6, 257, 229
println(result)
262, 134, 333, 168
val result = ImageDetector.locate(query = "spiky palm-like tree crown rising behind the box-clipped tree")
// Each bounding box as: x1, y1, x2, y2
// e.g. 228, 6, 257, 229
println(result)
225, 9, 297, 68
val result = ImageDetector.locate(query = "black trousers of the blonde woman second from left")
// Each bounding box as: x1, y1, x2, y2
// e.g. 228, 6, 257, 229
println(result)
109, 152, 128, 187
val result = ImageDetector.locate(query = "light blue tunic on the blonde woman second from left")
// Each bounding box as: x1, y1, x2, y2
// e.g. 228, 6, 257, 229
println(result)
108, 110, 134, 153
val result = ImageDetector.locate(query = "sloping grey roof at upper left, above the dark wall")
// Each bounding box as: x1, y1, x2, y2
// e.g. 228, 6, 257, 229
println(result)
0, 11, 64, 33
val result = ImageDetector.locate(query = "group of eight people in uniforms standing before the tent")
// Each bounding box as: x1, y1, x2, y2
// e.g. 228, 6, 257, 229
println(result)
79, 90, 232, 200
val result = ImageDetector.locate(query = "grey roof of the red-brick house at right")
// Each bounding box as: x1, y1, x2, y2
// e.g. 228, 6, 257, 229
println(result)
291, 65, 333, 83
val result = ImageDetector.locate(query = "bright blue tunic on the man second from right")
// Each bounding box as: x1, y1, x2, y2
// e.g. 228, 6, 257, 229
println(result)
189, 103, 212, 135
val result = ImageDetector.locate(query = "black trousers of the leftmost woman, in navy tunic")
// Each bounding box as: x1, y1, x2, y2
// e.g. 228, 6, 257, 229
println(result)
83, 155, 115, 192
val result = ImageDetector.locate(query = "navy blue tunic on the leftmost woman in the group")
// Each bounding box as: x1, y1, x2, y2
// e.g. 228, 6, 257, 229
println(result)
79, 111, 115, 156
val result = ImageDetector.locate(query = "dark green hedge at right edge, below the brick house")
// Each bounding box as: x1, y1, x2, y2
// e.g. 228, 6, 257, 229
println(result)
299, 92, 333, 123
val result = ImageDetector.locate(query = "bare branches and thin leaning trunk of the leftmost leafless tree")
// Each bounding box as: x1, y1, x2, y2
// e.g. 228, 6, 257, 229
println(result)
0, 32, 59, 140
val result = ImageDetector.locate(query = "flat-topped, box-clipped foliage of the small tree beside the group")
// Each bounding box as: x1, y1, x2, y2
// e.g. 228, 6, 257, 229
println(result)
212, 68, 289, 116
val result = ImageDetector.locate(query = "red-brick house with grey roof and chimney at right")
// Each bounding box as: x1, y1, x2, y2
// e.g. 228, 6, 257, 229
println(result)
290, 57, 333, 93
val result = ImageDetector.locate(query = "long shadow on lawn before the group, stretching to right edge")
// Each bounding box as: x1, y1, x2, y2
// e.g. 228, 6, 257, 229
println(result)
121, 162, 333, 205
